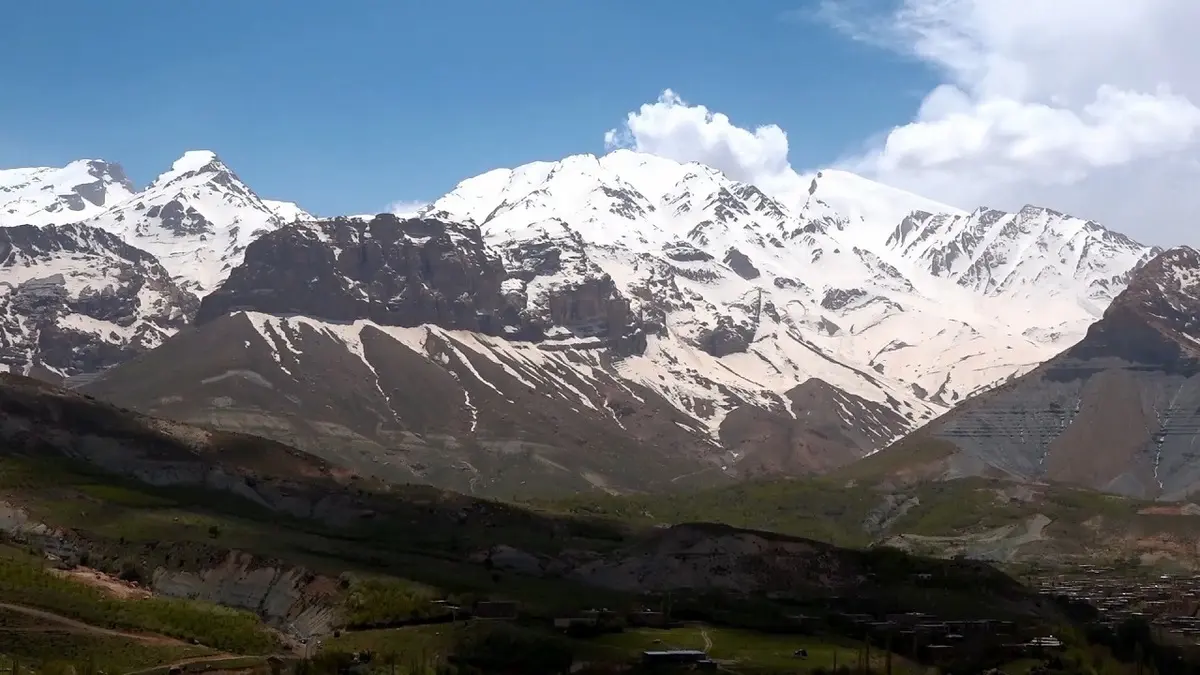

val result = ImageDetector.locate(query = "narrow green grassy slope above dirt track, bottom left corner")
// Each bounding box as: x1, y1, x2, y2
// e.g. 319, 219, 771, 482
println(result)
0, 557, 277, 653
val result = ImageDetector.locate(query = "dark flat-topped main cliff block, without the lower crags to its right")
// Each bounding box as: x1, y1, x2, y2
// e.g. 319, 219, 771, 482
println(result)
197, 214, 520, 335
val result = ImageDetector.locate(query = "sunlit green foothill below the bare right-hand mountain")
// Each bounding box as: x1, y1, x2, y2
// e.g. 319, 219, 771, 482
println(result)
532, 468, 1200, 565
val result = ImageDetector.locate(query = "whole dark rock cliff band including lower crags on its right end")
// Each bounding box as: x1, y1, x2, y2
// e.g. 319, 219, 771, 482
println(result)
197, 214, 637, 353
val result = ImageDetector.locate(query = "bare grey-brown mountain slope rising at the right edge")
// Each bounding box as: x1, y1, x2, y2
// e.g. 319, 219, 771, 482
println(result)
854, 247, 1200, 498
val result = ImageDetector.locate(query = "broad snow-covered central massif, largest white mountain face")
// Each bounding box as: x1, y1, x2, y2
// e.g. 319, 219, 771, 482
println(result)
425, 151, 1148, 424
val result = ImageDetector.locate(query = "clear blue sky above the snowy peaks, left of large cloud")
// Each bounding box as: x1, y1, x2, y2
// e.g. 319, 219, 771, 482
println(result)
0, 0, 936, 215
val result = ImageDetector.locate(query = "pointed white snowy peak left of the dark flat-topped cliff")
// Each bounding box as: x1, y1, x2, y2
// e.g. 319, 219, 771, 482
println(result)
86, 150, 311, 295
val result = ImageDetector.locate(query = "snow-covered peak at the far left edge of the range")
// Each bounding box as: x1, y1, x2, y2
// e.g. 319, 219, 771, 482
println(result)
0, 160, 136, 226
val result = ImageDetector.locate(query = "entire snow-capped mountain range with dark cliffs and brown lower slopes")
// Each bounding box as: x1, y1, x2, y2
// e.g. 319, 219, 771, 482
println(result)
0, 145, 1176, 495
